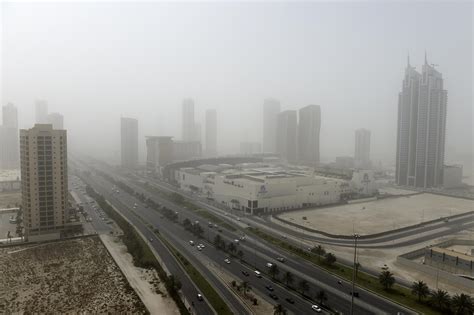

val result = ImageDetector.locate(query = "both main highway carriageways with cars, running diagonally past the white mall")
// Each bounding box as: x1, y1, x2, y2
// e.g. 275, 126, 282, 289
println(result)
75, 162, 410, 314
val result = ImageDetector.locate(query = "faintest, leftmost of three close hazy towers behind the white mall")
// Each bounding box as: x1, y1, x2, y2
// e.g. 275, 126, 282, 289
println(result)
263, 99, 280, 153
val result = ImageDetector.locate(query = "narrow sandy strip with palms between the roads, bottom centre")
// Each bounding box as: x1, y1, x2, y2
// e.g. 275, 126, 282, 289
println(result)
209, 264, 273, 315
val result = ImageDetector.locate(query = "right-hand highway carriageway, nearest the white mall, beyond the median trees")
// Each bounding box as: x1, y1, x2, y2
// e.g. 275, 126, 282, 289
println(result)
83, 162, 416, 314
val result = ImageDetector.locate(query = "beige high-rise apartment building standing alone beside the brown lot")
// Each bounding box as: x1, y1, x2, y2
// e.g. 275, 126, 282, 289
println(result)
20, 124, 69, 241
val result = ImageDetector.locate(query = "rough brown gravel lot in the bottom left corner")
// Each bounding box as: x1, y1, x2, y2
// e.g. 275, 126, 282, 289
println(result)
0, 237, 145, 314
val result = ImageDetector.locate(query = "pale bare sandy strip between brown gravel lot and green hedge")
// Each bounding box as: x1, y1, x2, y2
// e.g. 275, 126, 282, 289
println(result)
100, 235, 179, 314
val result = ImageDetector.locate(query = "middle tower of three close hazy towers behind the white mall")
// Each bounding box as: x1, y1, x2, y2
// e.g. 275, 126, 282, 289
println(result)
276, 110, 298, 164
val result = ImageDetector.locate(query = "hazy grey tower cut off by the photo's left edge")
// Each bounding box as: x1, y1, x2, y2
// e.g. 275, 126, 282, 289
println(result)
0, 103, 20, 169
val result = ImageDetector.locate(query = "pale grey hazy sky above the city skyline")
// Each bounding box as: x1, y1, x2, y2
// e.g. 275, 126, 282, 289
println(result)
0, 2, 474, 168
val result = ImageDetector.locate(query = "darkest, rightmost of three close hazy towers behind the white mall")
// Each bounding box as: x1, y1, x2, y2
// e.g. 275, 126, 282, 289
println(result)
298, 105, 321, 165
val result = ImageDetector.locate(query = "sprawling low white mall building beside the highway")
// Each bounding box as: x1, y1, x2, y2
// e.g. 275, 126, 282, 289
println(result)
176, 165, 352, 214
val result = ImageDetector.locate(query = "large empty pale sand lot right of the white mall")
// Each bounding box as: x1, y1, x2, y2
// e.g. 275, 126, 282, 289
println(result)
280, 194, 474, 234
